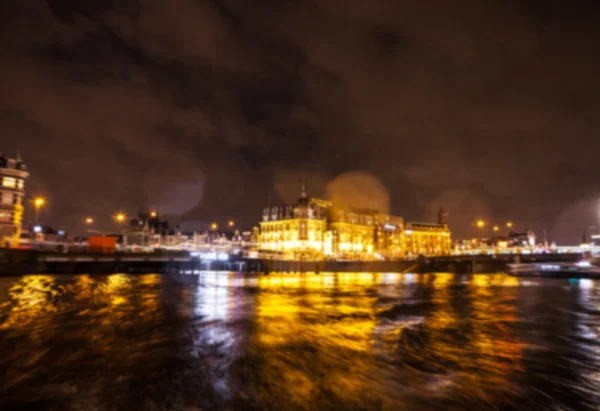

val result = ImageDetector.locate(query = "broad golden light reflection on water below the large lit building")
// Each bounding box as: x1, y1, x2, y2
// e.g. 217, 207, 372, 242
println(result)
256, 273, 379, 405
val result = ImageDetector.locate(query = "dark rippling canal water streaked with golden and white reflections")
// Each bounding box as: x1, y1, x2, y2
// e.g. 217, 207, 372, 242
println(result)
0, 272, 600, 411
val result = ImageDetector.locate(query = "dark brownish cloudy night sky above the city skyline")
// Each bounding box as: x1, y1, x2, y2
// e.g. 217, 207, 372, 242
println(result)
0, 0, 600, 243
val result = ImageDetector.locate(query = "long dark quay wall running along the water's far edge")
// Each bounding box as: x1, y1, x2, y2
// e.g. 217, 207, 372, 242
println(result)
0, 250, 581, 275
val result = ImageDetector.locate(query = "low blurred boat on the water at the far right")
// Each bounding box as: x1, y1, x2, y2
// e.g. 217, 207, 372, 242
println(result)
508, 258, 600, 280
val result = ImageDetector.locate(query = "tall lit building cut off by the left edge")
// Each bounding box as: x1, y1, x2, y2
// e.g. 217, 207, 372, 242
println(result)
0, 154, 29, 246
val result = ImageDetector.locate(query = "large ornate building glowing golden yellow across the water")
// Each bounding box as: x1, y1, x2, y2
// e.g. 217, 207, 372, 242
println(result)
259, 187, 451, 260
